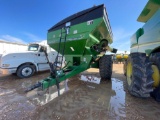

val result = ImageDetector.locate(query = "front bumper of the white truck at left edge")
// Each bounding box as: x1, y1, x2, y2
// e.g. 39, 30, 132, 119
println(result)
0, 68, 17, 75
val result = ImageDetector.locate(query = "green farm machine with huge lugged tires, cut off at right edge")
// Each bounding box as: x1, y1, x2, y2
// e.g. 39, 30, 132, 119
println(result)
124, 0, 160, 101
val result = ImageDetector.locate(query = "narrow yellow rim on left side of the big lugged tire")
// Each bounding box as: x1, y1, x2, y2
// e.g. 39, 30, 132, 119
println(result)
127, 62, 132, 86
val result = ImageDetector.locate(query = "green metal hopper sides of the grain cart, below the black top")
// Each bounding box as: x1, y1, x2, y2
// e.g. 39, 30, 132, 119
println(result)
47, 18, 112, 55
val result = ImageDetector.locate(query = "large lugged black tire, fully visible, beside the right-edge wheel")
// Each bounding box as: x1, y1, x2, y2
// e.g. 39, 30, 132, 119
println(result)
126, 53, 153, 98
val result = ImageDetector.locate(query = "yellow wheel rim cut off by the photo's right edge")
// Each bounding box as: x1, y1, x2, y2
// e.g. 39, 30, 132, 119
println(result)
152, 65, 160, 87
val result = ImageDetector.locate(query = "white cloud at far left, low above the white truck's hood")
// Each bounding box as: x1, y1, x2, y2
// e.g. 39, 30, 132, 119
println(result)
0, 35, 26, 44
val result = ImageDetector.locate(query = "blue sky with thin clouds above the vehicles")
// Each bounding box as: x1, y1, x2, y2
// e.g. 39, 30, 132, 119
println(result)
0, 0, 148, 51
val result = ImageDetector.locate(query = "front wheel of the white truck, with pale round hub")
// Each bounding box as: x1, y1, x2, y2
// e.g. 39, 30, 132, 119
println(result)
17, 64, 35, 78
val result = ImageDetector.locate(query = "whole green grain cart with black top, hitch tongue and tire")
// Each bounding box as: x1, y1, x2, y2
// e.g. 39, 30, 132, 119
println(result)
27, 4, 117, 91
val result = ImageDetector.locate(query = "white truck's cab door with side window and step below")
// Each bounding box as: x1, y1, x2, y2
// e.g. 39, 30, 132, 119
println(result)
37, 46, 49, 71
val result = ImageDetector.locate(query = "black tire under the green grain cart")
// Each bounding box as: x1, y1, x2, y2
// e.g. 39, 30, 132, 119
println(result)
99, 55, 113, 80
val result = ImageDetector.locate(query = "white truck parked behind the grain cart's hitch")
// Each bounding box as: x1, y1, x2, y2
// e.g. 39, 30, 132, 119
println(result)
0, 44, 61, 78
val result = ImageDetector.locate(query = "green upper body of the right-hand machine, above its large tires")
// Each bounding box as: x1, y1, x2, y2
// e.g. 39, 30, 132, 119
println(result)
131, 0, 160, 55
